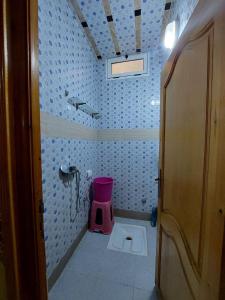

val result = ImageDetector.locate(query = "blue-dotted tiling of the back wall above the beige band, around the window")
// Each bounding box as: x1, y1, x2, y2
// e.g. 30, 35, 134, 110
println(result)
99, 49, 164, 128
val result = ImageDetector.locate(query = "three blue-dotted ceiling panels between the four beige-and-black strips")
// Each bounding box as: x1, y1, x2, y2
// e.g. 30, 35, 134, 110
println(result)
74, 0, 165, 58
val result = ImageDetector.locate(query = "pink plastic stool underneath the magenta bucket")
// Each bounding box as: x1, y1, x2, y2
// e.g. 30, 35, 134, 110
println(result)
90, 200, 114, 234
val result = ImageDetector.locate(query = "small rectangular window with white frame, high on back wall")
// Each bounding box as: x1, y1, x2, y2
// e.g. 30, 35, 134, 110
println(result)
107, 54, 148, 79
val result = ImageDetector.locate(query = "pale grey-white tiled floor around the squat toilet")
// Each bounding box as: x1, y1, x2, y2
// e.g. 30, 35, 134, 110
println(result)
49, 218, 157, 300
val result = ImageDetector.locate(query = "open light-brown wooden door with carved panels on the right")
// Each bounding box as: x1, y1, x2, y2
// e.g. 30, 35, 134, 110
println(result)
156, 0, 225, 300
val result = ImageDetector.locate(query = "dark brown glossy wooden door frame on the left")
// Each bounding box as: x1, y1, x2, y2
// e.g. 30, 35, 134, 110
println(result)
0, 0, 47, 300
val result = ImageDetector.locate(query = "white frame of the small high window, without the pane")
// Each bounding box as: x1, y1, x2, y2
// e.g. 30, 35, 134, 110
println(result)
106, 53, 149, 80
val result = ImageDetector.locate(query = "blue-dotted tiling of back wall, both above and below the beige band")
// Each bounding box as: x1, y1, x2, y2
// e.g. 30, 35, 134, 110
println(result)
98, 48, 164, 212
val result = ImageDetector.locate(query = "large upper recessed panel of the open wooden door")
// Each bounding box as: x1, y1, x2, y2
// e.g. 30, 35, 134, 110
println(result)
162, 32, 210, 267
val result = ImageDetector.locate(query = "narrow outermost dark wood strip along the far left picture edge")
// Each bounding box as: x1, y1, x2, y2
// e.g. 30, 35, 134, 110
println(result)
0, 1, 19, 299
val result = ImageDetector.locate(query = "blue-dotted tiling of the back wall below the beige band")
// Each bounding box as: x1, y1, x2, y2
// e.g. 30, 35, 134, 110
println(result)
98, 141, 159, 213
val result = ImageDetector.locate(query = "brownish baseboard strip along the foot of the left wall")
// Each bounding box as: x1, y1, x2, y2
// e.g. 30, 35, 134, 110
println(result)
48, 224, 88, 291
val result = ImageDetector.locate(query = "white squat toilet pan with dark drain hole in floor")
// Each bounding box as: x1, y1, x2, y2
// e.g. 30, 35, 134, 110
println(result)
107, 223, 148, 256
